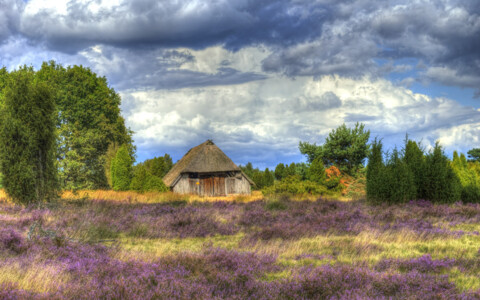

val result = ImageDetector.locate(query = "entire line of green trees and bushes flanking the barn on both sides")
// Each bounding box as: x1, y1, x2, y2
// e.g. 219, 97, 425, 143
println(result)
0, 61, 480, 204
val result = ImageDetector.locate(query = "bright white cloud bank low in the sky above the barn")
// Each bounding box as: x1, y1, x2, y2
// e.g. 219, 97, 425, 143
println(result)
124, 76, 480, 166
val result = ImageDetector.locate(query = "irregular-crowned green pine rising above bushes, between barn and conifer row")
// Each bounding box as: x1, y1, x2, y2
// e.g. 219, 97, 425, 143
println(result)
299, 123, 370, 174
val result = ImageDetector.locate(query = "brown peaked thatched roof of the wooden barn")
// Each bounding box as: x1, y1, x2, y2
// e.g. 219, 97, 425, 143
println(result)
163, 140, 253, 186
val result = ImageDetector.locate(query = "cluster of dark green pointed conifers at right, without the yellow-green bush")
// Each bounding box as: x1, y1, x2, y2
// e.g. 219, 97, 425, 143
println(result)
367, 139, 461, 203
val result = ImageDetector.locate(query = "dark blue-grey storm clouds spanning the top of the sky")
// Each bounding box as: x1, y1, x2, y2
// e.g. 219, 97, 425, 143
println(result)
0, 0, 480, 93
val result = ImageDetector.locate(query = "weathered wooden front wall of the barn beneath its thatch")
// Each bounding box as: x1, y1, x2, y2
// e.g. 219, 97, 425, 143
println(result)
173, 174, 251, 196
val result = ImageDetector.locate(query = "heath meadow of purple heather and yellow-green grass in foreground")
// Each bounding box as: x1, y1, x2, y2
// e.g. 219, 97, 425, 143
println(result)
0, 191, 480, 299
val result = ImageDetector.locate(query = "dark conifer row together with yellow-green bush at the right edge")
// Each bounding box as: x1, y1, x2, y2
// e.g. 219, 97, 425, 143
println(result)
366, 137, 480, 203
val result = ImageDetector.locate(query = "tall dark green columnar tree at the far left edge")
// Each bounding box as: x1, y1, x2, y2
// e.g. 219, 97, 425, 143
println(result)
0, 67, 58, 205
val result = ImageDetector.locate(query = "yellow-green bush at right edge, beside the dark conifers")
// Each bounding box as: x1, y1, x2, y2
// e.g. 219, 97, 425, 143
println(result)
452, 151, 480, 202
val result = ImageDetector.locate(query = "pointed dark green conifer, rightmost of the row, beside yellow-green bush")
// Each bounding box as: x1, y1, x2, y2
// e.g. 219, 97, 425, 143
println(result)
425, 142, 462, 203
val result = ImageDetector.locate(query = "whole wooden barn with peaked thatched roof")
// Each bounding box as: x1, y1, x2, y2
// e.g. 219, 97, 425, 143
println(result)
163, 140, 254, 196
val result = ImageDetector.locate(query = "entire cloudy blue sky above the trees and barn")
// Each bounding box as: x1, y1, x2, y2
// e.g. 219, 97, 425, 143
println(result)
0, 0, 480, 169
